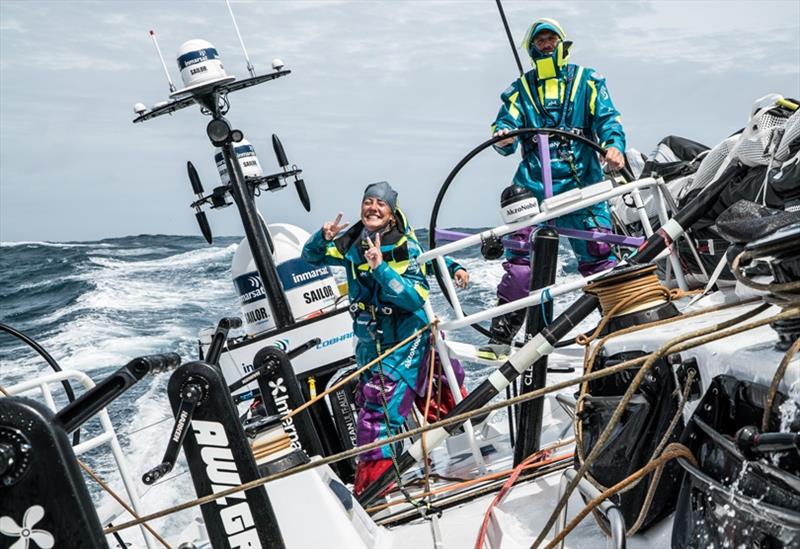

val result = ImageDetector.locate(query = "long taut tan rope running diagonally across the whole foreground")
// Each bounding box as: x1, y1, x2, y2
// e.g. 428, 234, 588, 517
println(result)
105, 306, 800, 534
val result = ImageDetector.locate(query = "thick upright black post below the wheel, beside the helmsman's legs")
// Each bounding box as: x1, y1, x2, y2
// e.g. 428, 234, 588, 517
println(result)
514, 227, 558, 466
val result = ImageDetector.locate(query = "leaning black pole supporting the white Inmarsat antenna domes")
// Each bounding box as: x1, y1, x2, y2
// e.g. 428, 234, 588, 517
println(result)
222, 137, 294, 329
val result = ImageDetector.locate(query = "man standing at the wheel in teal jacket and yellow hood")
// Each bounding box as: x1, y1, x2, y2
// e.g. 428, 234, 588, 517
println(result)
492, 18, 625, 344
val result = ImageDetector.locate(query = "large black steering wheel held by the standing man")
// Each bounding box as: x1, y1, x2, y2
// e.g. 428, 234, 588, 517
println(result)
428, 128, 634, 337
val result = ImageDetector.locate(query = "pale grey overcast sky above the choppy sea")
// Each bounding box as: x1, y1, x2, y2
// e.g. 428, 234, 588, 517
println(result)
0, 0, 800, 241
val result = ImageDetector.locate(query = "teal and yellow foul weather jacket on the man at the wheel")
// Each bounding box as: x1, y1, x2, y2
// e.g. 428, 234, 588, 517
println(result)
492, 64, 625, 200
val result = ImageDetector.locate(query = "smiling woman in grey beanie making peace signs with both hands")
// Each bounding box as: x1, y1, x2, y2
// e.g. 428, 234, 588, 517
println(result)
303, 181, 468, 495
